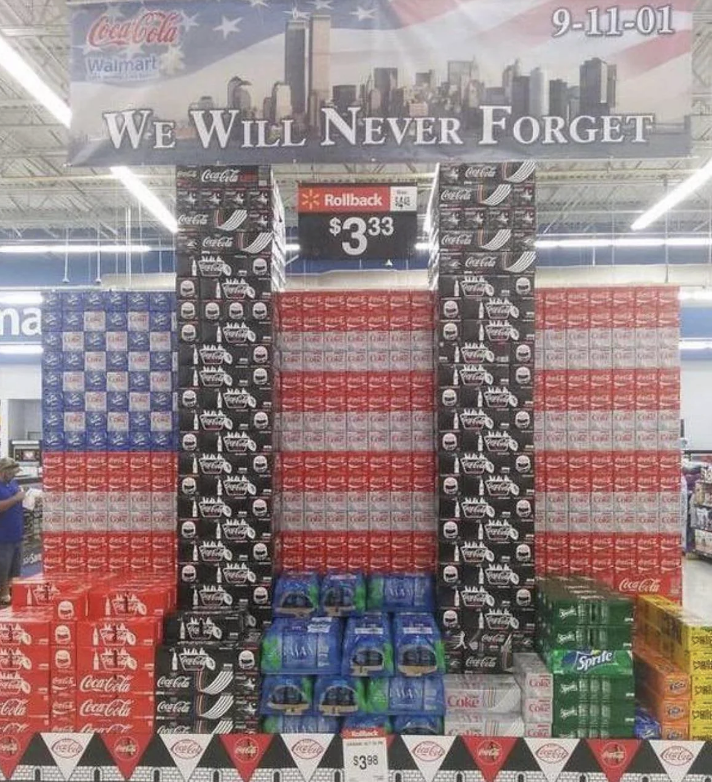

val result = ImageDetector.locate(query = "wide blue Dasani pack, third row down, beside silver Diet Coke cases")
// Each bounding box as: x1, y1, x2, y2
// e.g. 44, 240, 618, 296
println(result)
368, 676, 445, 716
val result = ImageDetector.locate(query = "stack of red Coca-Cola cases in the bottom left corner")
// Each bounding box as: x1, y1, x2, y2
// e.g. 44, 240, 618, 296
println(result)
0, 574, 175, 733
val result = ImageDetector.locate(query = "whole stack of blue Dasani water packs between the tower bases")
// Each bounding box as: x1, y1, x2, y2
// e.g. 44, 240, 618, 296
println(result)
260, 573, 445, 735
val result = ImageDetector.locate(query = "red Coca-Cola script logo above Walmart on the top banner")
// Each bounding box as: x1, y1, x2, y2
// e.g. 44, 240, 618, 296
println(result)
87, 11, 181, 49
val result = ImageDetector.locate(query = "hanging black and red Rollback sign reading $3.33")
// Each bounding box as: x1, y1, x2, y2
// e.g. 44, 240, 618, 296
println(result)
299, 185, 418, 261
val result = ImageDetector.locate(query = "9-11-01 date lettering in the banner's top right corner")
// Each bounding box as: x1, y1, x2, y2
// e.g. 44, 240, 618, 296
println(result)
551, 5, 675, 38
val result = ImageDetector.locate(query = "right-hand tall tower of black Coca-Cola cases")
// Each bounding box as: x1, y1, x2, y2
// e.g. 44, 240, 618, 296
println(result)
430, 163, 536, 673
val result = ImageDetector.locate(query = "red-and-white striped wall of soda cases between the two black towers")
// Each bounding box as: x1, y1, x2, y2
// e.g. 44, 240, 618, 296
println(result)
277, 290, 435, 573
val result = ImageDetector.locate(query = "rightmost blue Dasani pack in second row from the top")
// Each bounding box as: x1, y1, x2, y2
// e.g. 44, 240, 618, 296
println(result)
393, 613, 445, 676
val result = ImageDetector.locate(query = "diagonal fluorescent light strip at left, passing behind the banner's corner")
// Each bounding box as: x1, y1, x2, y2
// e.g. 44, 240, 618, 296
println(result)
0, 35, 178, 233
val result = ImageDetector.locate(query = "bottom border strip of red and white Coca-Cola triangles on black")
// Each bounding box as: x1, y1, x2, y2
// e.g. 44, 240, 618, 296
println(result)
5, 733, 712, 782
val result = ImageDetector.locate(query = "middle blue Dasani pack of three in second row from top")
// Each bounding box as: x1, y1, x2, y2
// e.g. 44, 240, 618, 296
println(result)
341, 614, 395, 677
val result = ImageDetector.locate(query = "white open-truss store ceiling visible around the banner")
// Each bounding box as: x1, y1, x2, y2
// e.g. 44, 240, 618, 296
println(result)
0, 0, 712, 242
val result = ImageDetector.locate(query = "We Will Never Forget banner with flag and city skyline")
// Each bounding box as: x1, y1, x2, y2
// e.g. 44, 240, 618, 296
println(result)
70, 0, 692, 166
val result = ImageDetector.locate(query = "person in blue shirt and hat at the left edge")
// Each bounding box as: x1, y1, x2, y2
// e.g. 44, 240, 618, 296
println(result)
0, 457, 25, 607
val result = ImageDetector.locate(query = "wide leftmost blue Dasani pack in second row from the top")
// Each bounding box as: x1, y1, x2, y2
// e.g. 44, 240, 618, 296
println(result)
262, 616, 341, 676
